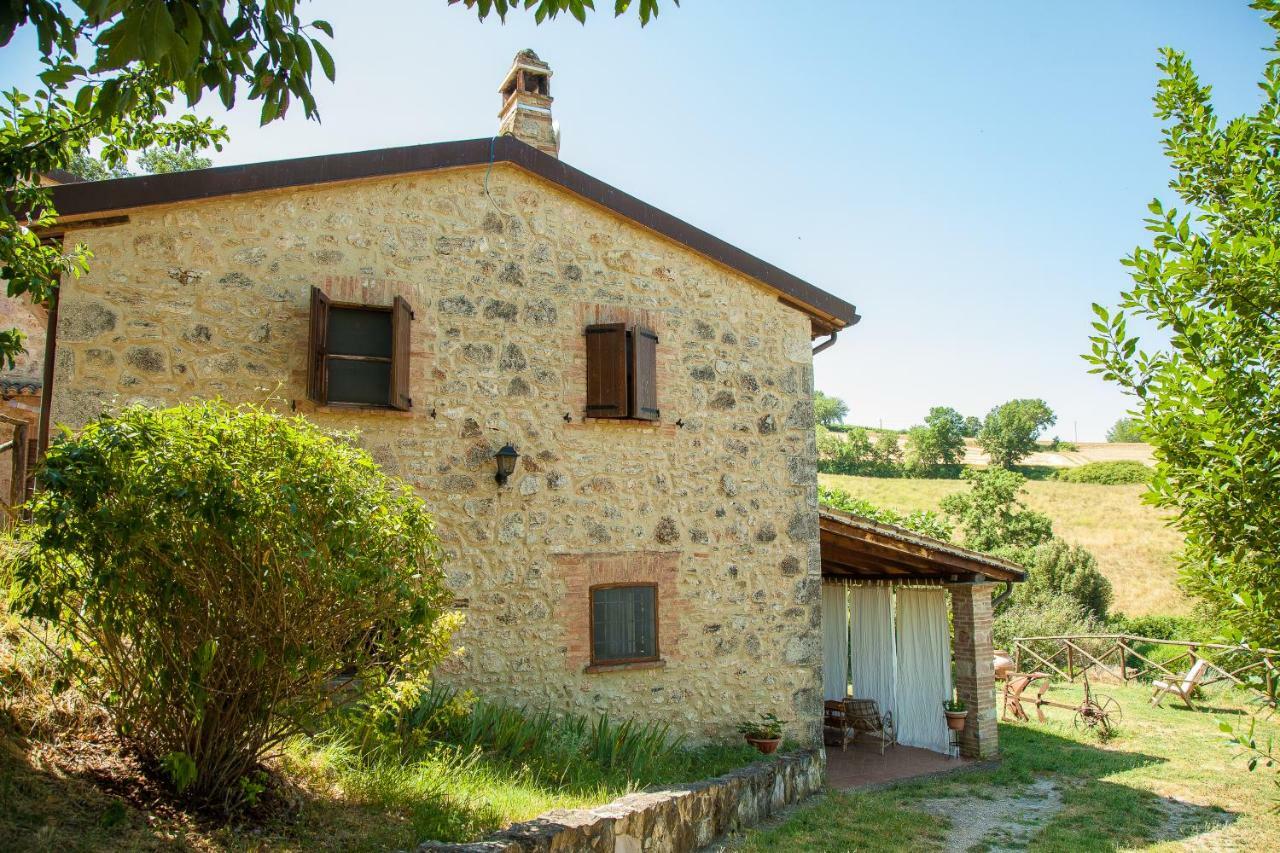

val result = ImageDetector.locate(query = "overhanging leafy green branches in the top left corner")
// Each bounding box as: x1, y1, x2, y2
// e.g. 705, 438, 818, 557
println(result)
0, 0, 678, 369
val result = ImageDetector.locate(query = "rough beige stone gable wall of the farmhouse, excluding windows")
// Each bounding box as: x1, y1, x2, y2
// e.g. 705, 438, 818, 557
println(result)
54, 164, 820, 743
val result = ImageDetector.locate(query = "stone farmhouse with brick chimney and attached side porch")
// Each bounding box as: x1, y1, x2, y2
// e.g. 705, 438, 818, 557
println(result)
6, 51, 1021, 756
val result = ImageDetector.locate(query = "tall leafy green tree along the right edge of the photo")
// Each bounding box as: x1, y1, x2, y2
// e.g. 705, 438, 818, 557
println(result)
1084, 0, 1280, 648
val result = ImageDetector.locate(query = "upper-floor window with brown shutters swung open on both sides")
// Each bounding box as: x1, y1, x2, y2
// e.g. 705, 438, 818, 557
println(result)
307, 287, 413, 410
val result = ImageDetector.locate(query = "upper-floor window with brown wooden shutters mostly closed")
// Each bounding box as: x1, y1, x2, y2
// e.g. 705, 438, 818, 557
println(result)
586, 323, 660, 420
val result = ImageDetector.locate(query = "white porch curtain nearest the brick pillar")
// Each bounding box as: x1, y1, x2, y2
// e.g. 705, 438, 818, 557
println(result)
896, 588, 951, 752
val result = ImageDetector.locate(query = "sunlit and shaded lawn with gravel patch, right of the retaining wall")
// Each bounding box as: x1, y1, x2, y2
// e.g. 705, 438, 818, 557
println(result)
730, 685, 1280, 853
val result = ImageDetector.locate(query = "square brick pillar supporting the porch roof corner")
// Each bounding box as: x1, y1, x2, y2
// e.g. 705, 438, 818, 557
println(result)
947, 584, 1000, 758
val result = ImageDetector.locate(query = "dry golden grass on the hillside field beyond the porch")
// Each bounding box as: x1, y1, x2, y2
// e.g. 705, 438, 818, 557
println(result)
819, 474, 1190, 616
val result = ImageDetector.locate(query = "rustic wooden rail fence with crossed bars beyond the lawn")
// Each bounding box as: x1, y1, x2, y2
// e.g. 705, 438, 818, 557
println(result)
1012, 634, 1280, 706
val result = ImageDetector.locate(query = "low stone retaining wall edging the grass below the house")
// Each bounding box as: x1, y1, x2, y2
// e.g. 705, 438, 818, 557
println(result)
419, 749, 826, 853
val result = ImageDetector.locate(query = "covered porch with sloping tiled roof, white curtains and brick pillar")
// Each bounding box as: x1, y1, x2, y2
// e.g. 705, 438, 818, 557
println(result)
818, 507, 1025, 758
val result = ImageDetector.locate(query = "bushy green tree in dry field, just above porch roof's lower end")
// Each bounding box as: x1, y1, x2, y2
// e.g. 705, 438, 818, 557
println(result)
941, 467, 1053, 551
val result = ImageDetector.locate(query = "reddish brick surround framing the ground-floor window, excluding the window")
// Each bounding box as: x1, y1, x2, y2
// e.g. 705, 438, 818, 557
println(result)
552, 551, 689, 674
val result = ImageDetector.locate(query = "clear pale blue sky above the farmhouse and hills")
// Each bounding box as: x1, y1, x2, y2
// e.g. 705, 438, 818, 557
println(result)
0, 0, 1270, 441
